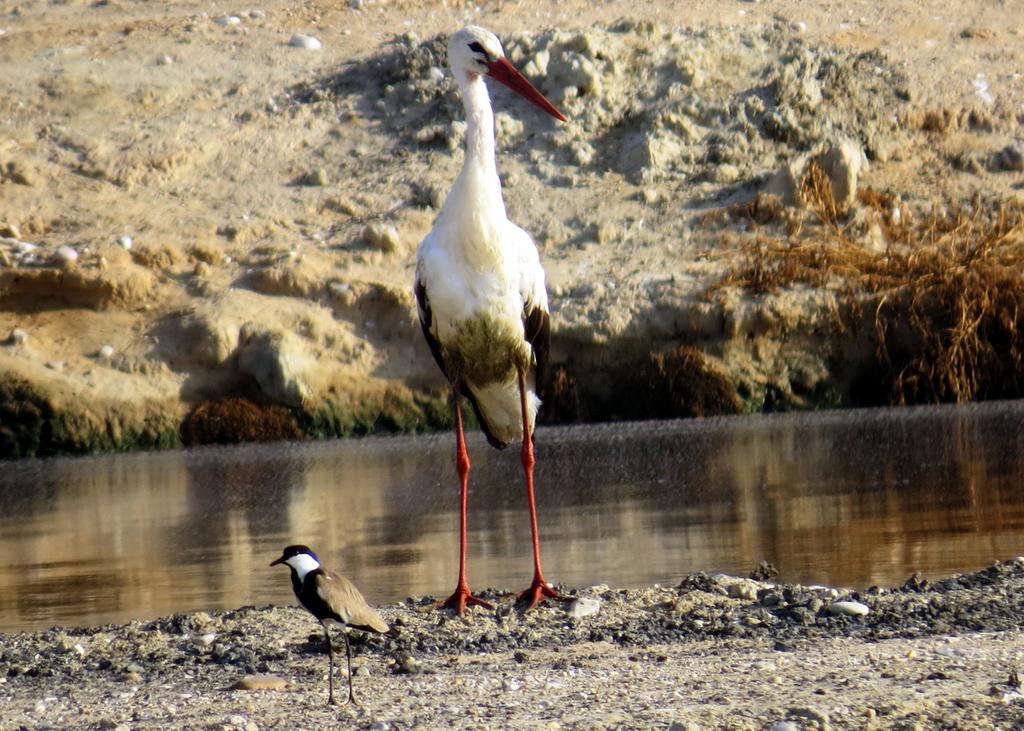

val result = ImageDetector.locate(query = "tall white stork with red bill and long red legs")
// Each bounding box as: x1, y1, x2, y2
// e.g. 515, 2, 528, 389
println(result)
415, 26, 565, 614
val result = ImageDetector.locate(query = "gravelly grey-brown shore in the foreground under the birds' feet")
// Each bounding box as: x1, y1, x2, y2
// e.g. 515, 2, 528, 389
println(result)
0, 558, 1024, 731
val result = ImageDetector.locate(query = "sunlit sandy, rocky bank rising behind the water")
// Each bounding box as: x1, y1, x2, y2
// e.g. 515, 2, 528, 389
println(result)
0, 0, 1024, 456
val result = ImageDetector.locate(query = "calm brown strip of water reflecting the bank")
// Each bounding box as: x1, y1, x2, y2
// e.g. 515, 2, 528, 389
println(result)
0, 403, 1024, 631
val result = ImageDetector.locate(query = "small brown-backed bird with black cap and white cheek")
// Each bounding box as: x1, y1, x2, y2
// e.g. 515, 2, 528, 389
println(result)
270, 546, 390, 704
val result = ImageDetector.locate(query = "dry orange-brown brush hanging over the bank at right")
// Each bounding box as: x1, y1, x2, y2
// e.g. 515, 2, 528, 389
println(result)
722, 160, 1024, 404
